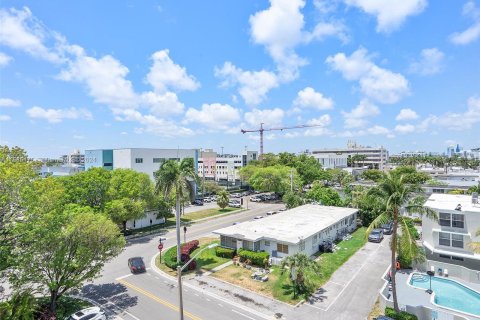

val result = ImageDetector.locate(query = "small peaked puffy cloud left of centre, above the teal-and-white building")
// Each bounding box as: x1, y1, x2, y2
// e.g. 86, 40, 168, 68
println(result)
146, 49, 200, 93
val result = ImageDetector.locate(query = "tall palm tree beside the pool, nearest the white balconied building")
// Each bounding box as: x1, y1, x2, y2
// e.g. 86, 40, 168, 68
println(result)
366, 173, 437, 312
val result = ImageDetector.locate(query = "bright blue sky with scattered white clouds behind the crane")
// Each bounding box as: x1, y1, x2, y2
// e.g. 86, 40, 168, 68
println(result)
0, 0, 480, 158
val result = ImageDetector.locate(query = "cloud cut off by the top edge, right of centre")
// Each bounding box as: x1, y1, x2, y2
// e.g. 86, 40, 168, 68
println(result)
344, 0, 428, 33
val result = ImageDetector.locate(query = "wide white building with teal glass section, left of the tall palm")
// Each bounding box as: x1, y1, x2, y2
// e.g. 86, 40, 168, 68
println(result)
85, 148, 199, 180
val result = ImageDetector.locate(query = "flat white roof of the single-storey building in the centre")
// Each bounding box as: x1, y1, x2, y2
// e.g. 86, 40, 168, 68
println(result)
213, 204, 358, 244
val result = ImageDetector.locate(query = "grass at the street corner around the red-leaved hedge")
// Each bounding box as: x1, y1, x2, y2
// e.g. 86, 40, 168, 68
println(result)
155, 238, 230, 276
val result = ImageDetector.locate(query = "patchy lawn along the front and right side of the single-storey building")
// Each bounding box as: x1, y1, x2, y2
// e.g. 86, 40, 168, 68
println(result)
212, 228, 367, 304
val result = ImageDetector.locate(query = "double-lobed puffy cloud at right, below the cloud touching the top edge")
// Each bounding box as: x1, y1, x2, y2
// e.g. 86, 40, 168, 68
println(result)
326, 48, 409, 104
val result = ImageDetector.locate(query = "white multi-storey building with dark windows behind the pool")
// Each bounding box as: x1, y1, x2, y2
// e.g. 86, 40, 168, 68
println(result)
422, 194, 480, 272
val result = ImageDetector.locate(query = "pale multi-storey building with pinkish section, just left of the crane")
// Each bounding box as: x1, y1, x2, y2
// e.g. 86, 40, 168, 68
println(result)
198, 149, 258, 182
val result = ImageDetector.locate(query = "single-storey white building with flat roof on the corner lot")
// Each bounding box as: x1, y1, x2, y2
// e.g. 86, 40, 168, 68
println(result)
213, 204, 358, 258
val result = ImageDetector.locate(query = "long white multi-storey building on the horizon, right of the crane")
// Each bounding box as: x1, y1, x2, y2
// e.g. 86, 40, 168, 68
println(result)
312, 142, 388, 170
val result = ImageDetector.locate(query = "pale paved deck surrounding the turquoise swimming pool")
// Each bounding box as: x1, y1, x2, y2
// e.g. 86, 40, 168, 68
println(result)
396, 270, 480, 320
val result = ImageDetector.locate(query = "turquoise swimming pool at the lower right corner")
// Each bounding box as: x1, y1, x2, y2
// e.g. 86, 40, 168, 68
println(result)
410, 273, 480, 316
